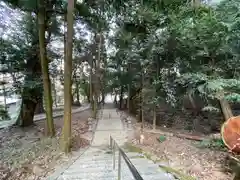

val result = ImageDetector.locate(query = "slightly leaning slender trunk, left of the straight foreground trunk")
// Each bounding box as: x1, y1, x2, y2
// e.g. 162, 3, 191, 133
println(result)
38, 0, 55, 136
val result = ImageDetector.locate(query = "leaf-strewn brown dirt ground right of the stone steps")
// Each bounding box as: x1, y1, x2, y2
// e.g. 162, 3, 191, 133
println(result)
125, 119, 233, 180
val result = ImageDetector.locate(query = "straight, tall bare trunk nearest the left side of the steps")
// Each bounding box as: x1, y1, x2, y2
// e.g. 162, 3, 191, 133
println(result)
62, 0, 75, 153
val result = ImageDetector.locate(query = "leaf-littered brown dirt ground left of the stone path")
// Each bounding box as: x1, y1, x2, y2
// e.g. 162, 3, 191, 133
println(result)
0, 110, 93, 180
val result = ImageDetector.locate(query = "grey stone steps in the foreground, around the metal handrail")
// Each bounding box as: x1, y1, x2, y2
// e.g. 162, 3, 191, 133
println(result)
57, 146, 175, 180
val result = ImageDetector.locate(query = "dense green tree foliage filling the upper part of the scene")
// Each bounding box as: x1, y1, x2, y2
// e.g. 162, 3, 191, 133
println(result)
0, 0, 240, 122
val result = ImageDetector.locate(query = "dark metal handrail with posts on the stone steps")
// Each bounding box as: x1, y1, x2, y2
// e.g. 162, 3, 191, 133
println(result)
110, 136, 143, 180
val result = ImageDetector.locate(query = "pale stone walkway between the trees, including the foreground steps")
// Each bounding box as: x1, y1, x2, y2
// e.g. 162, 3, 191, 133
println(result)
48, 106, 174, 180
